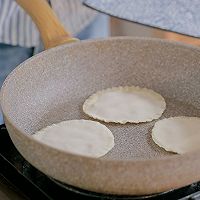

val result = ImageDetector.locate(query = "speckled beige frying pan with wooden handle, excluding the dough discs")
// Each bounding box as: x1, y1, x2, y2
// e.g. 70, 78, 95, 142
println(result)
1, 0, 200, 195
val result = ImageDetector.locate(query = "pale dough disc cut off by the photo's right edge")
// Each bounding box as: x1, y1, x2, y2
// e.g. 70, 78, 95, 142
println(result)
152, 117, 200, 154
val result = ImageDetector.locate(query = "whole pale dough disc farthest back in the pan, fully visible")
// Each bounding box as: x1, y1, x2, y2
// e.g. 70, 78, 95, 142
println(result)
83, 86, 166, 124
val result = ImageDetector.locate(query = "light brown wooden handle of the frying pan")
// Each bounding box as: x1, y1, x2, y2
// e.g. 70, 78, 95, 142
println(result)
16, 0, 78, 49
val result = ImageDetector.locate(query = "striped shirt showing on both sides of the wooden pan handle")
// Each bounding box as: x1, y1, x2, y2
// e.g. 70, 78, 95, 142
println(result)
0, 0, 96, 47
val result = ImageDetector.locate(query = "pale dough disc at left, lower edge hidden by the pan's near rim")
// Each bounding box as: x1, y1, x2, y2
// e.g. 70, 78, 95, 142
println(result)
33, 120, 114, 157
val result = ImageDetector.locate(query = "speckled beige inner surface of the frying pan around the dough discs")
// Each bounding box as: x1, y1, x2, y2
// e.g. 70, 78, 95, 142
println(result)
2, 39, 200, 159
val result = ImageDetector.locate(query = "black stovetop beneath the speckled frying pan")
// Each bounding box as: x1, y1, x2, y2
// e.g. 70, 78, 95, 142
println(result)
0, 125, 200, 200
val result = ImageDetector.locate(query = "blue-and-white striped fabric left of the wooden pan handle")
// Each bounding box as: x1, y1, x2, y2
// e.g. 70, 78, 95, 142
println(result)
0, 0, 39, 47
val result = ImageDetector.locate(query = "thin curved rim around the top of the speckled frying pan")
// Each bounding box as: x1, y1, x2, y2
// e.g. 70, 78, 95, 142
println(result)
0, 36, 200, 165
